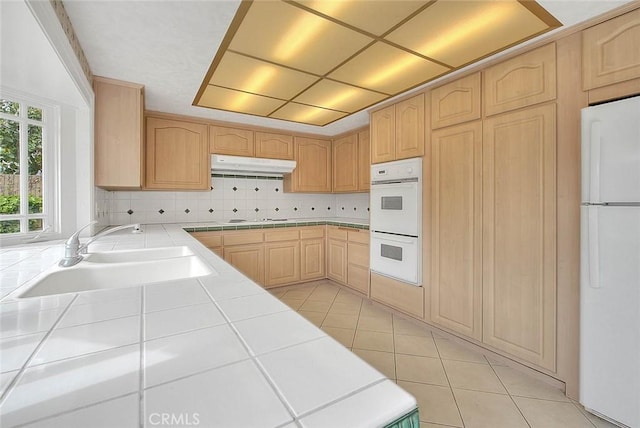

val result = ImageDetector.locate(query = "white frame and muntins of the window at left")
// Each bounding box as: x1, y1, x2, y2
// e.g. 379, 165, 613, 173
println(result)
0, 87, 61, 246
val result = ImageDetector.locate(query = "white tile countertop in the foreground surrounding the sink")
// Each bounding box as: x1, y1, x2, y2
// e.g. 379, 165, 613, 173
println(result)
0, 219, 417, 428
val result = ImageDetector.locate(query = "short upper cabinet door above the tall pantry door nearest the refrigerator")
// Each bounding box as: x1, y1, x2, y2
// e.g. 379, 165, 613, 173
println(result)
482, 43, 556, 116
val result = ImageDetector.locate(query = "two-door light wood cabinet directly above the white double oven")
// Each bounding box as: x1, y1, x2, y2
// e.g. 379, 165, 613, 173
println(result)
370, 94, 425, 163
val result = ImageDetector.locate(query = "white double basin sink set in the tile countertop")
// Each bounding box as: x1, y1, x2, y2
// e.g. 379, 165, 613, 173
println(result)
8, 246, 217, 299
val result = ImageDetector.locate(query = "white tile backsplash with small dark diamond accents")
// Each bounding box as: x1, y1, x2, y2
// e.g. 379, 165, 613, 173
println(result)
96, 176, 369, 224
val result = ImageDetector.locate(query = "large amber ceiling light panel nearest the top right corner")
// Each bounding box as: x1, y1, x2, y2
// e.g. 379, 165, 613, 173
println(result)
386, 0, 553, 67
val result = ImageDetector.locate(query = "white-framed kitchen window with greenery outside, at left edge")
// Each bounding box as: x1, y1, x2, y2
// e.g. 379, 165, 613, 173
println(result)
0, 92, 58, 237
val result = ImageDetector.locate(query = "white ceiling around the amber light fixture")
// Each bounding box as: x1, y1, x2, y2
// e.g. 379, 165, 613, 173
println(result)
64, 0, 630, 135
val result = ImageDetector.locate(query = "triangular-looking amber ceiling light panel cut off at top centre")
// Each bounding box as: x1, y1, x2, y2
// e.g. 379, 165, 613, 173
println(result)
296, 0, 428, 36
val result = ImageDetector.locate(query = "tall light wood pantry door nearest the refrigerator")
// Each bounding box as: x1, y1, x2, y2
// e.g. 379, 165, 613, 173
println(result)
482, 104, 556, 371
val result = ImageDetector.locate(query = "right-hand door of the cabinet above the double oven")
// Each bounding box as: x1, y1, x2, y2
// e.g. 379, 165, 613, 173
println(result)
395, 94, 424, 159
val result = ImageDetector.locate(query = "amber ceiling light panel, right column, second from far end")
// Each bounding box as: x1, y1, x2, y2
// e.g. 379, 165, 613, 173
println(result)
294, 79, 387, 113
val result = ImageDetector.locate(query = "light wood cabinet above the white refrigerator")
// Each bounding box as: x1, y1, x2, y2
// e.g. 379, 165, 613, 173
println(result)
582, 9, 640, 90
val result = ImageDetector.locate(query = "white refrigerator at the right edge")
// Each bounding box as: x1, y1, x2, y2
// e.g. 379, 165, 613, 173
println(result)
580, 97, 640, 428
